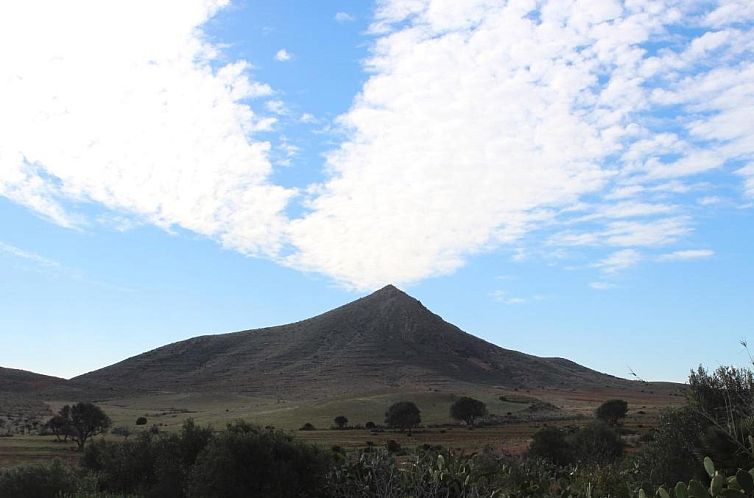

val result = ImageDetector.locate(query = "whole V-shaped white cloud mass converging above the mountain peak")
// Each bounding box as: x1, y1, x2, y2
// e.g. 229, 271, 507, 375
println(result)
0, 0, 754, 289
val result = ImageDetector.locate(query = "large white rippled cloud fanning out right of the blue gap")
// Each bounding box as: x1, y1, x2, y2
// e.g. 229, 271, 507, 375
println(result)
288, 0, 754, 288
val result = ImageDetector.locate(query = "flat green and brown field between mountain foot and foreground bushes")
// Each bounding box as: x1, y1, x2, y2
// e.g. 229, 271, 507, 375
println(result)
0, 385, 684, 467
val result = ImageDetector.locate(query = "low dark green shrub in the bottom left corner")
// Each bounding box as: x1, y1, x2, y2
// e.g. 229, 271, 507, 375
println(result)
0, 460, 78, 498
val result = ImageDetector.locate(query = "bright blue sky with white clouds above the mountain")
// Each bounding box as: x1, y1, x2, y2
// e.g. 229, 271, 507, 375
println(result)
0, 0, 754, 381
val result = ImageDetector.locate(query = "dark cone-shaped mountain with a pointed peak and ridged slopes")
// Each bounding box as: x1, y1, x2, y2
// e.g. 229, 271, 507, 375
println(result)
73, 286, 635, 399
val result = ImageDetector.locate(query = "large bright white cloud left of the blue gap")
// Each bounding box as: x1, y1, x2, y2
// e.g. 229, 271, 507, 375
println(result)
0, 0, 294, 254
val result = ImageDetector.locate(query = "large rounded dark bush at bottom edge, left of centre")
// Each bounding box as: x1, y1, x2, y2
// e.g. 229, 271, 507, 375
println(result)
187, 421, 330, 498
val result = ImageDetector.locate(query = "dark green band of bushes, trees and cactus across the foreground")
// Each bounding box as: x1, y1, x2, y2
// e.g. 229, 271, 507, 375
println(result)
0, 367, 754, 498
